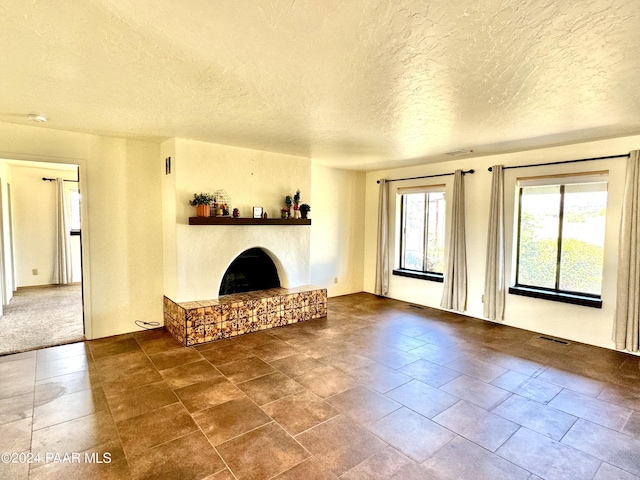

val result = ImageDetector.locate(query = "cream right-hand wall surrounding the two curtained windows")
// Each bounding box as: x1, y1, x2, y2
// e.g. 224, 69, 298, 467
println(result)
364, 136, 640, 348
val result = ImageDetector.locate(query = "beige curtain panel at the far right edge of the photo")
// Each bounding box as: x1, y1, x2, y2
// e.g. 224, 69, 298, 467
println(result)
613, 150, 640, 352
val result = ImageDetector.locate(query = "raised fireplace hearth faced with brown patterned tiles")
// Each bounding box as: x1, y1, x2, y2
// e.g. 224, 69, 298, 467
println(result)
164, 286, 327, 347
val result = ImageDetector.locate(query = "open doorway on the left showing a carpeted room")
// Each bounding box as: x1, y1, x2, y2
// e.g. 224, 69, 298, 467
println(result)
0, 159, 85, 355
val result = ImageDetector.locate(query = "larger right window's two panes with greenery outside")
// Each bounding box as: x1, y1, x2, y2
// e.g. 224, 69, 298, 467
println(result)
517, 183, 607, 295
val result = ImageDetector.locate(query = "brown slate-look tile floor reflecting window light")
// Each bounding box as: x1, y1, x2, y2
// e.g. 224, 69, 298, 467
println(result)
0, 294, 640, 480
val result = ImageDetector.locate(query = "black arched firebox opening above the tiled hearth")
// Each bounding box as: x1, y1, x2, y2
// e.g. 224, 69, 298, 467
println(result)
219, 248, 280, 295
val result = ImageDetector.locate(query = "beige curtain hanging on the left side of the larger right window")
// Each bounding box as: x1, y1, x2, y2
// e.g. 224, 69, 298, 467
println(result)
484, 165, 505, 320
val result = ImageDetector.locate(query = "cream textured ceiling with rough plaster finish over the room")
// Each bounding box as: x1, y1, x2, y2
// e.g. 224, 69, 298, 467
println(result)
0, 0, 640, 169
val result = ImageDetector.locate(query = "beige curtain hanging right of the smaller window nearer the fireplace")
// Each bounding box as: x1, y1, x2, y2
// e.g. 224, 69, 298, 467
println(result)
440, 170, 467, 312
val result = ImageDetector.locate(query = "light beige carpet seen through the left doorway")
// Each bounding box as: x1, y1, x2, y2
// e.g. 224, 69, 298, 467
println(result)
0, 284, 84, 355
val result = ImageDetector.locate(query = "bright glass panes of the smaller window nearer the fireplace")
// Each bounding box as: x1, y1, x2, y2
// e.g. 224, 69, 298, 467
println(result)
400, 192, 445, 273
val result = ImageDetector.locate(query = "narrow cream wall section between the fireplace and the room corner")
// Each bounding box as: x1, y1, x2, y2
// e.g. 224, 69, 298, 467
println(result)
309, 166, 365, 297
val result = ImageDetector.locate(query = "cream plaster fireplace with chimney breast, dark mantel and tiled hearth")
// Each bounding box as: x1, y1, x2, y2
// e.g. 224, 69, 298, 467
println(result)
161, 138, 320, 346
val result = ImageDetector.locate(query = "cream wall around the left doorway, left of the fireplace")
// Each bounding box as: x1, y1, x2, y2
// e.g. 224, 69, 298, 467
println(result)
0, 123, 163, 338
